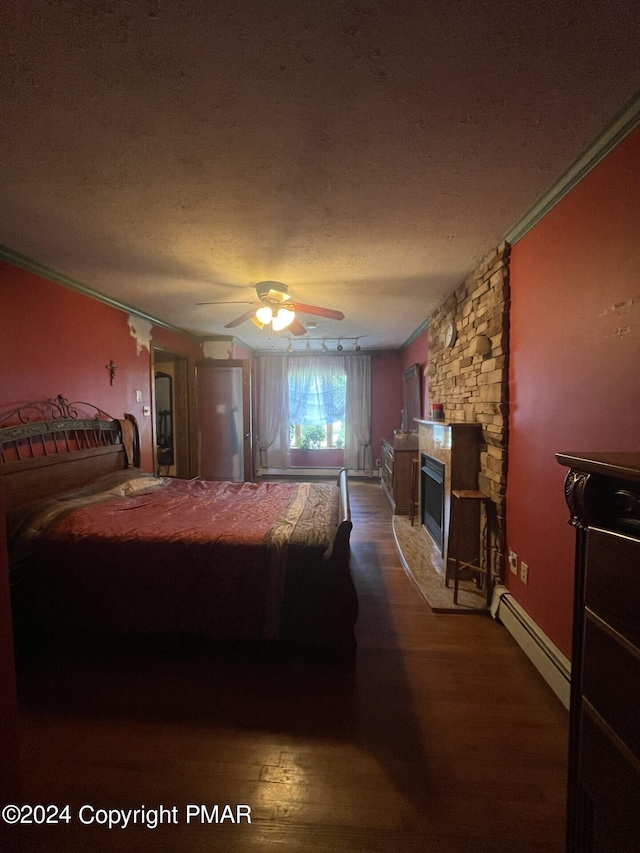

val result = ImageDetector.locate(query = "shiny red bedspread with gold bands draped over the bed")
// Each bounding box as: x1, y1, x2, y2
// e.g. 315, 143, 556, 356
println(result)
16, 475, 338, 641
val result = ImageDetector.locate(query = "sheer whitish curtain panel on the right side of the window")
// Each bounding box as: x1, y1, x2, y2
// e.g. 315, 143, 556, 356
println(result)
344, 355, 373, 477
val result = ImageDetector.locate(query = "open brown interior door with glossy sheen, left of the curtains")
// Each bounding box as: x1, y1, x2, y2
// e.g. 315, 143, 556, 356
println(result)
196, 359, 253, 482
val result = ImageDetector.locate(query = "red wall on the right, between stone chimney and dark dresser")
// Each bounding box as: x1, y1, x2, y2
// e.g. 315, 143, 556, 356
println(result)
507, 129, 640, 657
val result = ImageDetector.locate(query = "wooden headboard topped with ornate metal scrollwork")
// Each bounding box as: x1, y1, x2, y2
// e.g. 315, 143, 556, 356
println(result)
0, 394, 140, 509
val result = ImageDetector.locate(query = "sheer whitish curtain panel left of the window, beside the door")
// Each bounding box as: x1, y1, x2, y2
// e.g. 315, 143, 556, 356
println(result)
257, 356, 291, 468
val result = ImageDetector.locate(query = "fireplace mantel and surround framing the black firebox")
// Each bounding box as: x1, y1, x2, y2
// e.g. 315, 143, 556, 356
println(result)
417, 420, 482, 569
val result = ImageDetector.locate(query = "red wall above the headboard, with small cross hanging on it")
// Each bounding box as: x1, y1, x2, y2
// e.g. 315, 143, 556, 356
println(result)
0, 261, 201, 471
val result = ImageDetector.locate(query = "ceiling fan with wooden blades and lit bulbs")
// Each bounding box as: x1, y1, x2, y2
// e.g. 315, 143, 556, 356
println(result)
198, 281, 344, 335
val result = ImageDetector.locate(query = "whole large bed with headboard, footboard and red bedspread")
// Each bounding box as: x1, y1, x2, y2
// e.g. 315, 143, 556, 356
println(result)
0, 396, 358, 658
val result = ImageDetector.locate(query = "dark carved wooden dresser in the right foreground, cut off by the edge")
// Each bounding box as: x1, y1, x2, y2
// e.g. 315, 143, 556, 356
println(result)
556, 453, 640, 853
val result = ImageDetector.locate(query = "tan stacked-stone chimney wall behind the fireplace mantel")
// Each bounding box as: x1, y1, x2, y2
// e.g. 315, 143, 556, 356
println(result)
428, 243, 510, 578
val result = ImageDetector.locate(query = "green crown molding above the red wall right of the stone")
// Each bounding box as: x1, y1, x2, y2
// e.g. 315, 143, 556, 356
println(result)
504, 92, 640, 246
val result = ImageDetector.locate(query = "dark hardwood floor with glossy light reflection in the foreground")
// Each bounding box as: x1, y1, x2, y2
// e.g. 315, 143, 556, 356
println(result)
3, 482, 567, 853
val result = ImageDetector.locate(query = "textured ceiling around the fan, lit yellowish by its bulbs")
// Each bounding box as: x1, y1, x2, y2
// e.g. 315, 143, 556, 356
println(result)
0, 0, 640, 349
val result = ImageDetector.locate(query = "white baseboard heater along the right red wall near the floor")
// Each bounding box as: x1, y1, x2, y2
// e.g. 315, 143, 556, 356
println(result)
491, 586, 571, 709
